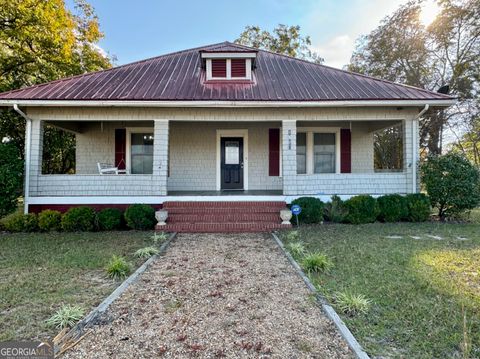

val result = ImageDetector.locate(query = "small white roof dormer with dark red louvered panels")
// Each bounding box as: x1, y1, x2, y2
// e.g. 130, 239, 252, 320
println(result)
202, 52, 256, 81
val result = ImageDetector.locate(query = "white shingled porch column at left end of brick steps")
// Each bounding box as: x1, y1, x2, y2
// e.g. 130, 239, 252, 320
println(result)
153, 120, 168, 196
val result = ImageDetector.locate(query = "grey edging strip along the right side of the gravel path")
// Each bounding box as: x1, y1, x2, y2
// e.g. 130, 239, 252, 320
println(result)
272, 232, 370, 359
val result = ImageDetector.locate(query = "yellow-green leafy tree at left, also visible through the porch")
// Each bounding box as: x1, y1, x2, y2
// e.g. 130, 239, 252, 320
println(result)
0, 0, 111, 170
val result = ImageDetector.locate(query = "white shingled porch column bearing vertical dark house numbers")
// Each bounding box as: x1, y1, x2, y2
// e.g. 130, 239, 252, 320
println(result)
282, 120, 297, 195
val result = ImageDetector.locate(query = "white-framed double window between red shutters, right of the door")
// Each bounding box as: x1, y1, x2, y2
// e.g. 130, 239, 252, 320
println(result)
297, 128, 340, 174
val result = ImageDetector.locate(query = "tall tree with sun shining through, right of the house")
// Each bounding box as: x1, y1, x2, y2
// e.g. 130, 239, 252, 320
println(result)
348, 0, 480, 154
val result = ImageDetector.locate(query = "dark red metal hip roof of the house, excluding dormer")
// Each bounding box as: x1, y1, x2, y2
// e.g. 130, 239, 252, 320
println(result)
0, 42, 452, 101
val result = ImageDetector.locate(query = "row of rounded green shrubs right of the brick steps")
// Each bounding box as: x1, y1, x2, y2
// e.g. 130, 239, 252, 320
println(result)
292, 193, 431, 224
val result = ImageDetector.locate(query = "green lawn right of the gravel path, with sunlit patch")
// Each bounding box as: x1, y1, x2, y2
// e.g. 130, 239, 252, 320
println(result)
282, 223, 480, 358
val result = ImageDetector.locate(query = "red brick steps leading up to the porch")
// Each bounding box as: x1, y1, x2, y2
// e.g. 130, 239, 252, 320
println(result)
156, 201, 291, 233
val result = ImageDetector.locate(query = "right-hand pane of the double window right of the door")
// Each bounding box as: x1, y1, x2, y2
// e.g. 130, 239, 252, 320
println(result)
313, 133, 335, 173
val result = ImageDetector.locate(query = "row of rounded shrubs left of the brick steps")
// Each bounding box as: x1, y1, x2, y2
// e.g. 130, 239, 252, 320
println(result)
1, 204, 156, 232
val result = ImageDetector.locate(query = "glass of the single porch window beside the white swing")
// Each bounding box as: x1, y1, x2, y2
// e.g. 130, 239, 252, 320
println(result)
131, 133, 153, 174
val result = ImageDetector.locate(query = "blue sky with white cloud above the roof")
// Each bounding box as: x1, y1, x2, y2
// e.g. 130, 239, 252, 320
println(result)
76, 0, 406, 68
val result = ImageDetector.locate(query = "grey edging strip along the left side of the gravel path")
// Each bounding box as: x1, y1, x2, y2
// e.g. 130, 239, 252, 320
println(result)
54, 232, 177, 356
